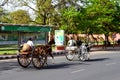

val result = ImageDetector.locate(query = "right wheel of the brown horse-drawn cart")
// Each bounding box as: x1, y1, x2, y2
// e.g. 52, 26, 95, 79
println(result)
32, 54, 47, 69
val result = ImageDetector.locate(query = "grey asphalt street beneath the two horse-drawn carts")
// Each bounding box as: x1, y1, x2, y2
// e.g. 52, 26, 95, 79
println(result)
0, 51, 120, 80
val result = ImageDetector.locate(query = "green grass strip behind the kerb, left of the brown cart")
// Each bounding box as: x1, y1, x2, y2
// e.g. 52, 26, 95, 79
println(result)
0, 45, 17, 55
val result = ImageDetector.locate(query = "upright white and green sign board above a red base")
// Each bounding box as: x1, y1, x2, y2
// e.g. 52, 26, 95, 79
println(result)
55, 30, 64, 46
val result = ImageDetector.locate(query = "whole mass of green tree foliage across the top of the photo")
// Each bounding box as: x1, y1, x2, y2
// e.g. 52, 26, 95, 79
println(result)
0, 0, 120, 35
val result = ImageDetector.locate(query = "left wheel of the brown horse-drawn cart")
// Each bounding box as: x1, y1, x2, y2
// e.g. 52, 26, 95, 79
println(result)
17, 54, 32, 68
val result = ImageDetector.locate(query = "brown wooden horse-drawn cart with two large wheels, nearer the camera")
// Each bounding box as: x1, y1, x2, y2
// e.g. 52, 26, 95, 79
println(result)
17, 45, 53, 69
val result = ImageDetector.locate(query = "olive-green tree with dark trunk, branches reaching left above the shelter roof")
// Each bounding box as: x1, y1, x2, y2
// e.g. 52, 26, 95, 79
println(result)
19, 0, 56, 25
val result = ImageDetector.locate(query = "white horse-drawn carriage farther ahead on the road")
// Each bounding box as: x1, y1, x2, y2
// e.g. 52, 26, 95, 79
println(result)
65, 43, 90, 61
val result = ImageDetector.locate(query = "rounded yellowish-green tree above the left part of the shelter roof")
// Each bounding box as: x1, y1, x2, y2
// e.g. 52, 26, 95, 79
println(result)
10, 10, 31, 24
